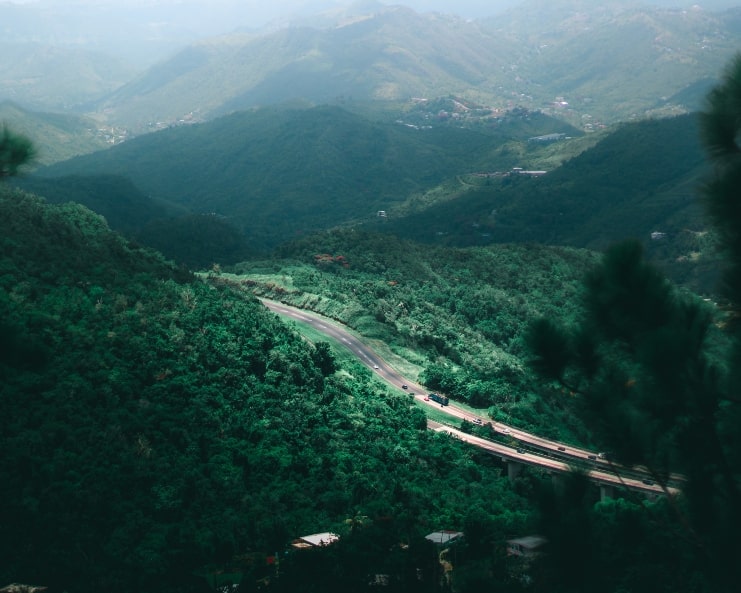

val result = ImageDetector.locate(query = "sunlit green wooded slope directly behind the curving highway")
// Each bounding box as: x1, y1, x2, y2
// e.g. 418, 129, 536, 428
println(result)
240, 230, 598, 442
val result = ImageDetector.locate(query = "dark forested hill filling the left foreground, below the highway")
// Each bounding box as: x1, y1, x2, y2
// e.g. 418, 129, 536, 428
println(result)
0, 187, 531, 593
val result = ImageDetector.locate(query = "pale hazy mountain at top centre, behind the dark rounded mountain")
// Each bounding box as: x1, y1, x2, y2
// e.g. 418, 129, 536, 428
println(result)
92, 4, 511, 129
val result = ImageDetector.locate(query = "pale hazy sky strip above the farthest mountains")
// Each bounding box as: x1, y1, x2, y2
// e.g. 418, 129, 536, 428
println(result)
0, 0, 741, 67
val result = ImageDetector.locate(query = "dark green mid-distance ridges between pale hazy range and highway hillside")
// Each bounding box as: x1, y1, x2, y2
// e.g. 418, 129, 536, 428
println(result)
27, 106, 707, 292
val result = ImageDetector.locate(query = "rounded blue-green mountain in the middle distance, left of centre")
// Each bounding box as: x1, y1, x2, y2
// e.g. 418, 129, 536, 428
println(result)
39, 106, 572, 250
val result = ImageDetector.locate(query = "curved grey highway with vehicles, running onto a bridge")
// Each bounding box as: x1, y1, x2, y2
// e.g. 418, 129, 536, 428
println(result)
260, 298, 681, 493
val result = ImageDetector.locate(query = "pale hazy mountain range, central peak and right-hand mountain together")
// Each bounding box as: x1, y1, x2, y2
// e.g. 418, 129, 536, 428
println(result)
88, 0, 741, 131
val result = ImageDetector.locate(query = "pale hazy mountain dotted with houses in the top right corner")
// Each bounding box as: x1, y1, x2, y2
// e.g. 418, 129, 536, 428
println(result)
488, 0, 741, 122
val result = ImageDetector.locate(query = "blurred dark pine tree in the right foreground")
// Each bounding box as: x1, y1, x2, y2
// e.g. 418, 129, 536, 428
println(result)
528, 55, 741, 591
